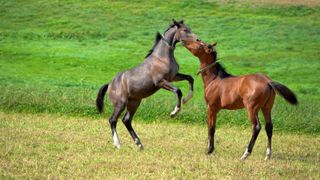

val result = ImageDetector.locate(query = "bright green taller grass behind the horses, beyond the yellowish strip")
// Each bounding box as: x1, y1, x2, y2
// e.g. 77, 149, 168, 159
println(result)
0, 0, 320, 134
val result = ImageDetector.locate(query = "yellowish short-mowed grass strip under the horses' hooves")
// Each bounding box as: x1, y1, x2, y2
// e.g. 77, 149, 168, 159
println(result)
0, 112, 320, 179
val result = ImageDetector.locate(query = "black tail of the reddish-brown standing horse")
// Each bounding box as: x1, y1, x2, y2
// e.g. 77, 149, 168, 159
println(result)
269, 81, 298, 105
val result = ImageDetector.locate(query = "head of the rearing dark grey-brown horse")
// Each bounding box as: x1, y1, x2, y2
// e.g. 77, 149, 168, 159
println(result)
164, 20, 198, 46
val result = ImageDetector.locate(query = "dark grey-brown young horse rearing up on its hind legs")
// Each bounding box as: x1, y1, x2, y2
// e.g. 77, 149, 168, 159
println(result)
96, 20, 198, 149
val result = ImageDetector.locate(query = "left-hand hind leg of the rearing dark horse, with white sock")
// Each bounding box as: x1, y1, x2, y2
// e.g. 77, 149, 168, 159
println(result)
109, 103, 124, 149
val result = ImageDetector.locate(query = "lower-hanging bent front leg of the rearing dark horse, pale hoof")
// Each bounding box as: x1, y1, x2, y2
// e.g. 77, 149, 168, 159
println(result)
158, 79, 182, 117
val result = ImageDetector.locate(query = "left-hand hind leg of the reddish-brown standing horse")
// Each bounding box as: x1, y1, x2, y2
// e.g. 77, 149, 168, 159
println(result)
241, 109, 261, 160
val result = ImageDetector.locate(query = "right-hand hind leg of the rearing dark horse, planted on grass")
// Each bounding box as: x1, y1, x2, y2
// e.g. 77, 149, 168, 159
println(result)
122, 100, 143, 150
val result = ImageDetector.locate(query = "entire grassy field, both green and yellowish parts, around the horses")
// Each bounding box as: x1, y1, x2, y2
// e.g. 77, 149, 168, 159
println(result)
0, 0, 320, 179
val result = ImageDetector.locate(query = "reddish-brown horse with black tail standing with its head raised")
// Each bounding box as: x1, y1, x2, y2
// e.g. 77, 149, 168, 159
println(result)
185, 41, 298, 160
